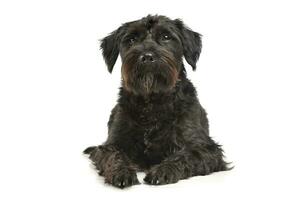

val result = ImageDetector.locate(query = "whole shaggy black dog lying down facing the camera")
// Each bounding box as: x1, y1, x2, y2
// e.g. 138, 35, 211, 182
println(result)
84, 16, 228, 188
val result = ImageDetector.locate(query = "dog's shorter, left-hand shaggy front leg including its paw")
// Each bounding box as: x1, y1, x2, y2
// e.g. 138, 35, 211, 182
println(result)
84, 145, 139, 188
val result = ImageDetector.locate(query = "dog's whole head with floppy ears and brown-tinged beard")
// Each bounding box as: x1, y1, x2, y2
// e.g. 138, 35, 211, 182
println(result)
101, 15, 202, 95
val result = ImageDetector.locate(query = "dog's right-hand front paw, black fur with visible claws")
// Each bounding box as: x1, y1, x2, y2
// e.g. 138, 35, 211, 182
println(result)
144, 164, 180, 185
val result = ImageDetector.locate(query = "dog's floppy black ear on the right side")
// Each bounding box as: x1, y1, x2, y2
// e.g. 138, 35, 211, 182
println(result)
174, 19, 202, 70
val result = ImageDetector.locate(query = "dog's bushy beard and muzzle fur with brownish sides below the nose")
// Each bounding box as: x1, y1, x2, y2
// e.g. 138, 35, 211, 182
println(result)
122, 52, 178, 95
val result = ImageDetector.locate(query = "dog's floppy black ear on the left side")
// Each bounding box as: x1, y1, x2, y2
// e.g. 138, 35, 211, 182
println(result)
100, 27, 123, 73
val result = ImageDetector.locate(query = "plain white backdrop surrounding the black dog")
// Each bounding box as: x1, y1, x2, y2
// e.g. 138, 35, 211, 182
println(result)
0, 0, 301, 200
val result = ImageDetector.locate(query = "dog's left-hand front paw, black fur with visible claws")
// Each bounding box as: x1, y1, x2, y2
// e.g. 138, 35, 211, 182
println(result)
106, 169, 139, 188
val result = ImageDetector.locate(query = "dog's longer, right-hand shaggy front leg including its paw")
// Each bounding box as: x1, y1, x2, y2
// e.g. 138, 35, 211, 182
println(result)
144, 141, 227, 185
